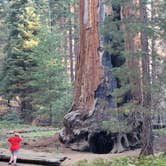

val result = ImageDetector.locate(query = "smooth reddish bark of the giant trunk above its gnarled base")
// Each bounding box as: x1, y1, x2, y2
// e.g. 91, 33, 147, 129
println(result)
71, 0, 103, 111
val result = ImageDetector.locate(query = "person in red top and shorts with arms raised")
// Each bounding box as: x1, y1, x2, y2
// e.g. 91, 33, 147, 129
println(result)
8, 133, 22, 166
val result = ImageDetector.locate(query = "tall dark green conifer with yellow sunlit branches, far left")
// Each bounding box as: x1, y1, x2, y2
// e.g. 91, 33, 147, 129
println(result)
1, 0, 40, 121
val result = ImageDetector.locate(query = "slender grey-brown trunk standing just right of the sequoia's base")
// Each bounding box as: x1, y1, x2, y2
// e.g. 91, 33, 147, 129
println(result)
140, 0, 153, 156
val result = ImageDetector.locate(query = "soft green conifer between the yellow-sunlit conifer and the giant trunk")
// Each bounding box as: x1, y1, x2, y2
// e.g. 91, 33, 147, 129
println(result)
31, 27, 72, 126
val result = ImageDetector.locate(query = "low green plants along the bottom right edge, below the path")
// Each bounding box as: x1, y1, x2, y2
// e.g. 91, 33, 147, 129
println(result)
73, 154, 166, 166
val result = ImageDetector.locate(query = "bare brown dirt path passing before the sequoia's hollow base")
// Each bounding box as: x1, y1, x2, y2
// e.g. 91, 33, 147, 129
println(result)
20, 135, 140, 166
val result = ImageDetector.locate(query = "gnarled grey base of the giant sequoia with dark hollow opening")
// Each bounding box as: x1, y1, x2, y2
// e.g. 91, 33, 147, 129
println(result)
59, 108, 140, 154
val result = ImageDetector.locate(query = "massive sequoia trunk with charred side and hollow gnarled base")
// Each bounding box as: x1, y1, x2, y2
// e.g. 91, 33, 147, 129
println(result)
60, 0, 140, 153
